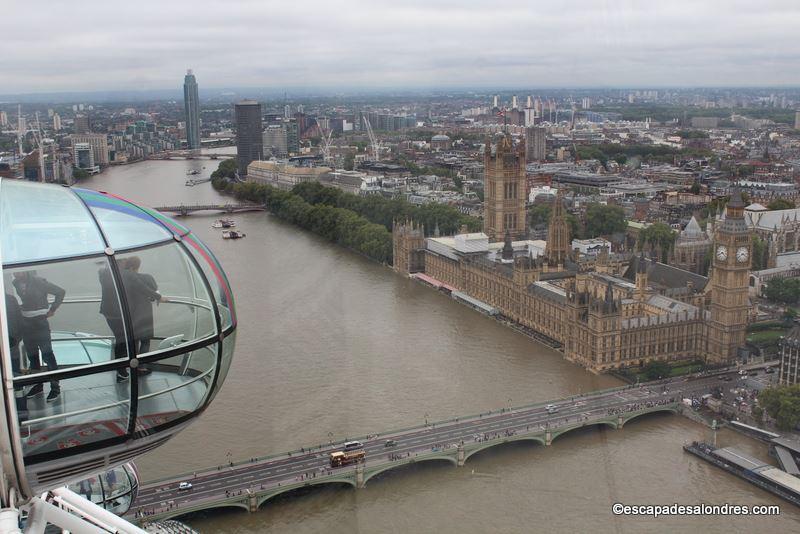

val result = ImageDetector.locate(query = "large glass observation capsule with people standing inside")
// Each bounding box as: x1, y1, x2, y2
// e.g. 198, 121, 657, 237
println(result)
0, 179, 236, 497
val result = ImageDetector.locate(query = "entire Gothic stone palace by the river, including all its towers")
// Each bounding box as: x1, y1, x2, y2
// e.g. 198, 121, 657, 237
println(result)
393, 135, 752, 372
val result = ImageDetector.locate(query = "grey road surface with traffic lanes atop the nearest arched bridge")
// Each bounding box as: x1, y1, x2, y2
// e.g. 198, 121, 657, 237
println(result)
130, 371, 735, 520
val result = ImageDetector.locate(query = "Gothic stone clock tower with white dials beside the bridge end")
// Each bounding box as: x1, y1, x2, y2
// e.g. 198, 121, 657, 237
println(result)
707, 190, 753, 363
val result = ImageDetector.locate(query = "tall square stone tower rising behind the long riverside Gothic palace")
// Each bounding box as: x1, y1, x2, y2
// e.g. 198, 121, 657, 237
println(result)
483, 134, 527, 241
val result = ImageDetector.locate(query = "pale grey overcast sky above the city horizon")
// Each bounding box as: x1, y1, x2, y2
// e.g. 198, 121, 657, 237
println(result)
0, 0, 800, 94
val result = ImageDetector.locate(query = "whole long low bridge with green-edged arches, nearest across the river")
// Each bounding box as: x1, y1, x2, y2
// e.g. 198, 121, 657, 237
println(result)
130, 375, 732, 523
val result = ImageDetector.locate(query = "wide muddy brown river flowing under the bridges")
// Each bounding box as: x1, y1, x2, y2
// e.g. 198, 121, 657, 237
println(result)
80, 154, 800, 533
